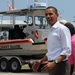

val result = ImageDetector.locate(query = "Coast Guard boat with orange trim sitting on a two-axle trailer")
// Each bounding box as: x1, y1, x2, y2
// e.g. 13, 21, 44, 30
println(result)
0, 3, 49, 72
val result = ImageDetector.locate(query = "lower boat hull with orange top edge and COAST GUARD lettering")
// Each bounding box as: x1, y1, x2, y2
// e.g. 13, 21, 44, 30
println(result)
0, 39, 47, 56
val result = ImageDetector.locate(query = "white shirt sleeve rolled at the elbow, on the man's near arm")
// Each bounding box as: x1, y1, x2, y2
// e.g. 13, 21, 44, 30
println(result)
60, 28, 71, 57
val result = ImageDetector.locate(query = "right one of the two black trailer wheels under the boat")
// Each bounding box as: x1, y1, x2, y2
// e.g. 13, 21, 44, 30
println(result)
9, 58, 21, 72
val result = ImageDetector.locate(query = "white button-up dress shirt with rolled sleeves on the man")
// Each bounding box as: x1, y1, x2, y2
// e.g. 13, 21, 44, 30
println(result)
46, 21, 71, 61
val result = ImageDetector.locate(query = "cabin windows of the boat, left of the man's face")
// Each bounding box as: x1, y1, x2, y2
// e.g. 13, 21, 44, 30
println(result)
28, 16, 48, 27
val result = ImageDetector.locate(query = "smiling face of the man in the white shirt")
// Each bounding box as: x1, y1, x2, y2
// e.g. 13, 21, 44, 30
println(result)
45, 8, 58, 26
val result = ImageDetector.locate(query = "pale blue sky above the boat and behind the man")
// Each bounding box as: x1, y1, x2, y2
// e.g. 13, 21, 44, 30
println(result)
0, 0, 75, 22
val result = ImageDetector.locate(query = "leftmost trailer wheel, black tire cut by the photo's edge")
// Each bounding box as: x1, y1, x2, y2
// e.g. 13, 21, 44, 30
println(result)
0, 58, 9, 71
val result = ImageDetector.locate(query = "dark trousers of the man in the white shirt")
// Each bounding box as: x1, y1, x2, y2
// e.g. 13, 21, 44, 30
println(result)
49, 61, 70, 75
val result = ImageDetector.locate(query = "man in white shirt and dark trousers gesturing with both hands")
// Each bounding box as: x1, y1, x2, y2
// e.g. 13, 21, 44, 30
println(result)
32, 6, 71, 75
